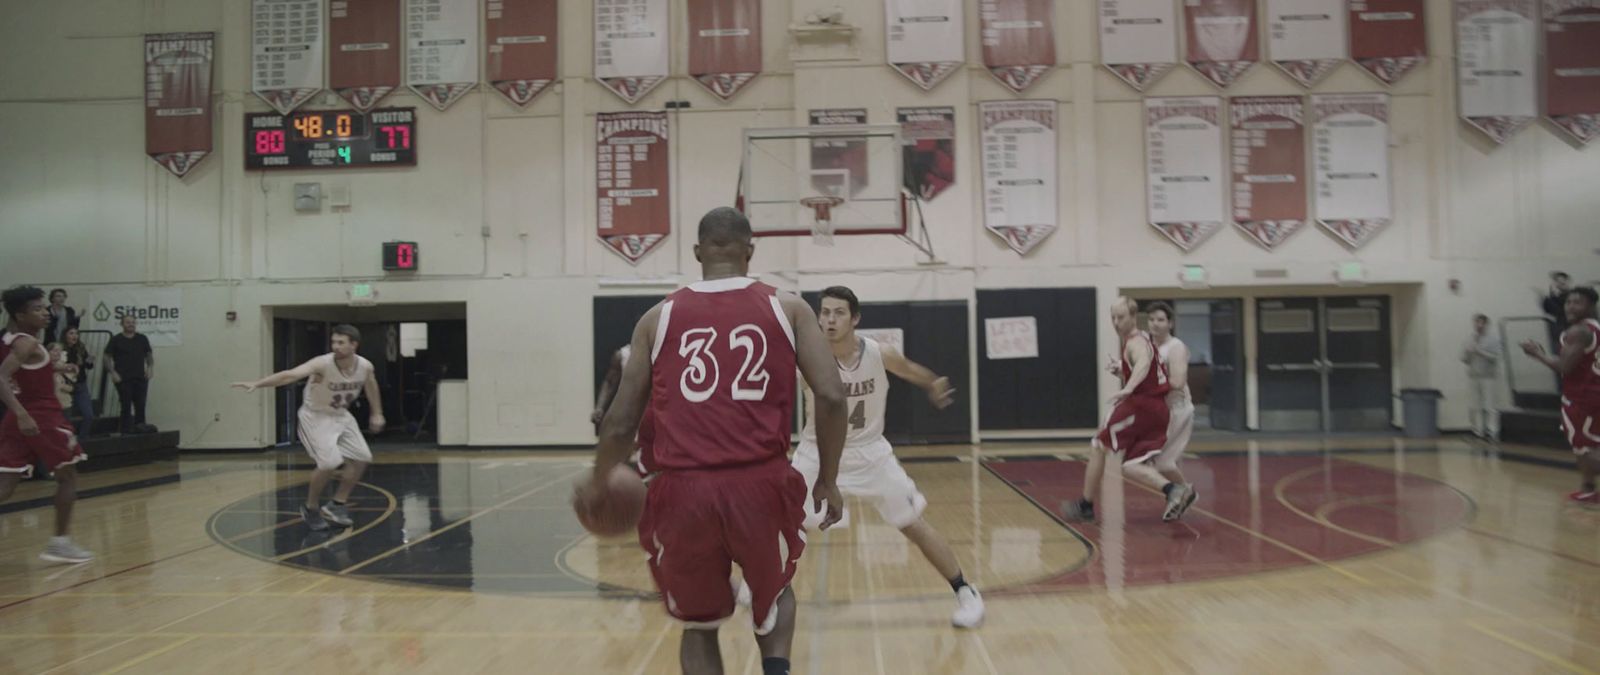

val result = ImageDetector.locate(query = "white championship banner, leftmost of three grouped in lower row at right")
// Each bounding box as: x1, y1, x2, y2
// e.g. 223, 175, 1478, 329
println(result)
1144, 96, 1226, 251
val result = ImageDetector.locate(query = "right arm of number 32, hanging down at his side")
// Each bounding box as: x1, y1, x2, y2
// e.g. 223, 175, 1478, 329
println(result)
779, 294, 848, 529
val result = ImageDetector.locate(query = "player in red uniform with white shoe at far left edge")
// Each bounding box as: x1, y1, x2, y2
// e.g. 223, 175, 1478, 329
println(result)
0, 286, 94, 563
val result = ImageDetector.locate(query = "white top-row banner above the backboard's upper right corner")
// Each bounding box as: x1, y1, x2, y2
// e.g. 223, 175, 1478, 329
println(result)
883, 0, 966, 91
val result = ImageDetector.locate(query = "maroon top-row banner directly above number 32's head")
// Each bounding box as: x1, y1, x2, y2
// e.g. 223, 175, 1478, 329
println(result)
690, 0, 762, 101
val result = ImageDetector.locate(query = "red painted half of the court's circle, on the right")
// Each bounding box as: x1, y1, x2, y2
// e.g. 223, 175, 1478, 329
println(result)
987, 456, 1472, 592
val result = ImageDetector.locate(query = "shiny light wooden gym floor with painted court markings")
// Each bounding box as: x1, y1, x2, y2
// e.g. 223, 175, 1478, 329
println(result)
0, 437, 1600, 675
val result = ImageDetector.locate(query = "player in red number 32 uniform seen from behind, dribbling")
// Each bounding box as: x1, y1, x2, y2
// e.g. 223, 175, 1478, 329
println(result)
576, 208, 845, 675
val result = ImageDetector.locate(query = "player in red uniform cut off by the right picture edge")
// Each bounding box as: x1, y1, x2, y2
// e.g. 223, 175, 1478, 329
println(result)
1522, 286, 1600, 504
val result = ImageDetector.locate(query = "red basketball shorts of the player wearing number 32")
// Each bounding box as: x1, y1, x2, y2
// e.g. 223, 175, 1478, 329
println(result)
638, 459, 805, 635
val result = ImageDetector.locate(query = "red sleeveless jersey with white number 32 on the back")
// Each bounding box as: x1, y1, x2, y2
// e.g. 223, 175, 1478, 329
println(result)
650, 277, 795, 470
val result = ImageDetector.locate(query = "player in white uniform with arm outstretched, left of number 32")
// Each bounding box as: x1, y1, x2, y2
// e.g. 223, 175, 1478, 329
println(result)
234, 323, 384, 531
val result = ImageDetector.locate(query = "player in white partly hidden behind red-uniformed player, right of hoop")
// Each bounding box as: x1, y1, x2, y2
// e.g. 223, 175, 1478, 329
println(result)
1117, 302, 1197, 521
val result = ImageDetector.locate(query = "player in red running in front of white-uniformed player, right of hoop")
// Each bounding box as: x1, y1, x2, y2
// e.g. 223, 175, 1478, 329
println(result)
1062, 296, 1171, 521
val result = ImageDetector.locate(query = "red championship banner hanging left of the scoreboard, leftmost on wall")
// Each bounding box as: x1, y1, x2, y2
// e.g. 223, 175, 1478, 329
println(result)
144, 34, 216, 178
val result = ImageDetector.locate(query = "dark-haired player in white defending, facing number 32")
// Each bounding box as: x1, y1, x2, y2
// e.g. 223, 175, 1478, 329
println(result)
794, 286, 984, 629
